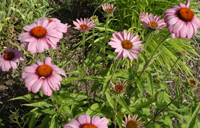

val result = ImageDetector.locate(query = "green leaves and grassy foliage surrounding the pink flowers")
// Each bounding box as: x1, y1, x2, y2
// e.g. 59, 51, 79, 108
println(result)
0, 0, 200, 128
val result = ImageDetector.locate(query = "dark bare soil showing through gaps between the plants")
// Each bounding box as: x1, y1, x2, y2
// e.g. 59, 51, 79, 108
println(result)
0, 0, 200, 128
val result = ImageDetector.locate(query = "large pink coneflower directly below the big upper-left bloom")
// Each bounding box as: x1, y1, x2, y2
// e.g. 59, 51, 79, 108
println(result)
22, 57, 66, 96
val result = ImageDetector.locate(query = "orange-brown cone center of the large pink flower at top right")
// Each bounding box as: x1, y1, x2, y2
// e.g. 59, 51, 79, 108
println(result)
178, 8, 194, 22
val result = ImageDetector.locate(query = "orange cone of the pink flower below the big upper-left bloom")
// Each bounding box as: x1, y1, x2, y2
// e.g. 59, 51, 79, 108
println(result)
37, 65, 52, 78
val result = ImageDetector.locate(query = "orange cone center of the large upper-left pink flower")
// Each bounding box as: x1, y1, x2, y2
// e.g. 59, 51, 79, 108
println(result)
31, 26, 46, 39
